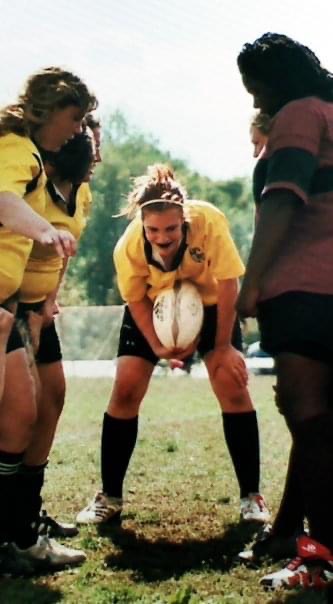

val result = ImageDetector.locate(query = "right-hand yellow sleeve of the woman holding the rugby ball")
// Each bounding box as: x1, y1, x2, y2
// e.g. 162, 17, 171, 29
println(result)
202, 206, 244, 281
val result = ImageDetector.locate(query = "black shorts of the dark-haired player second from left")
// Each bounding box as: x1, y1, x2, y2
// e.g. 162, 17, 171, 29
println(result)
17, 302, 62, 364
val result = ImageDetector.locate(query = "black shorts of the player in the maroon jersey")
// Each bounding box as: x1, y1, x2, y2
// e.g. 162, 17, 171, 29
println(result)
258, 291, 333, 363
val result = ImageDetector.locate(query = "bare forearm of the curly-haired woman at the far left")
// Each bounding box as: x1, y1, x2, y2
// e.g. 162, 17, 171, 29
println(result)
0, 192, 50, 241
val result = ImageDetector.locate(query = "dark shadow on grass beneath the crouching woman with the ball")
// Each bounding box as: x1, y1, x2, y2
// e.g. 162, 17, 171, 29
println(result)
99, 523, 258, 582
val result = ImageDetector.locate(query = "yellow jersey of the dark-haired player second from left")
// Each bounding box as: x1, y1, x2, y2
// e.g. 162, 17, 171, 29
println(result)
20, 183, 92, 302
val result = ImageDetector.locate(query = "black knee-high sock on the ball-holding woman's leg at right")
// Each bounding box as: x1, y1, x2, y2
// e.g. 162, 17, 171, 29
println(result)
222, 411, 260, 497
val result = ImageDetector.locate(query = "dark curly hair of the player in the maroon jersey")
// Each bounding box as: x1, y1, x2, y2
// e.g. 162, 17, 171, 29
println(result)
237, 32, 333, 108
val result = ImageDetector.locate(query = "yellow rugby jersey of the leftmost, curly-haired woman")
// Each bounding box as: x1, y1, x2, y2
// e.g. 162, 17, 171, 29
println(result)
0, 133, 46, 303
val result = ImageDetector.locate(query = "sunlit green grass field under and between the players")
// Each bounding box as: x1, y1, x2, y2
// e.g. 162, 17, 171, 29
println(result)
0, 376, 324, 604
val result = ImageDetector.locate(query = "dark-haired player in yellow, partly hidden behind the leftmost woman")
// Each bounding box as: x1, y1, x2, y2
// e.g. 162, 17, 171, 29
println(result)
17, 131, 95, 537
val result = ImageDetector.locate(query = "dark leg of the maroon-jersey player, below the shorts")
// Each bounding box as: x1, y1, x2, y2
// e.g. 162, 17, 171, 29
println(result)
276, 354, 333, 548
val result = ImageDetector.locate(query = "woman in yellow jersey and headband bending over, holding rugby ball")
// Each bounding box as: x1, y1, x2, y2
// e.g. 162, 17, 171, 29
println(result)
77, 165, 269, 523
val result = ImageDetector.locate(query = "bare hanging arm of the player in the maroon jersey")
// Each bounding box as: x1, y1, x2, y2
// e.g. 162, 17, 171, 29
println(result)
244, 191, 300, 286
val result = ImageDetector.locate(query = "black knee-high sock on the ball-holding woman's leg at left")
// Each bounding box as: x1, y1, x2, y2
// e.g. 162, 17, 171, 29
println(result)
101, 413, 138, 497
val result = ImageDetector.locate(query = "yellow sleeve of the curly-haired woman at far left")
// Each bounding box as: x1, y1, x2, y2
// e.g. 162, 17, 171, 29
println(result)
0, 135, 40, 197
